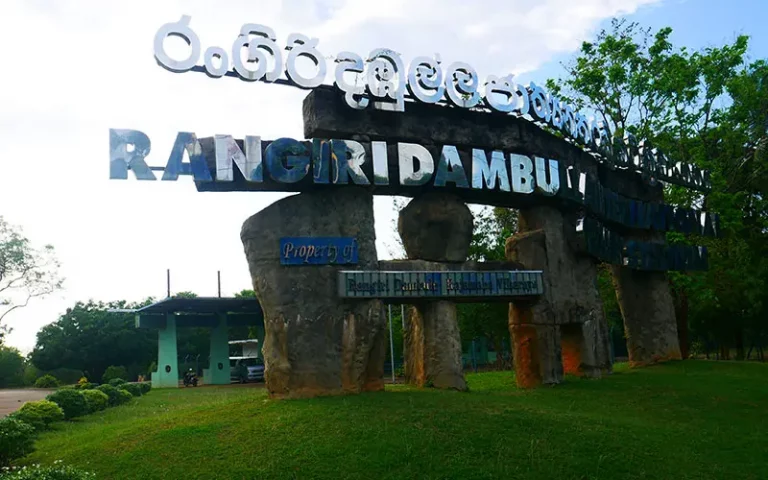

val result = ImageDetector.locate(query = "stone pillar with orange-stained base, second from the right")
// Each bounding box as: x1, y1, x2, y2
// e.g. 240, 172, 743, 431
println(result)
506, 207, 611, 387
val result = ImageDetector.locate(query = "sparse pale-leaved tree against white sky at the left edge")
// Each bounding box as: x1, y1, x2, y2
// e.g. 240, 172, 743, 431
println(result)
0, 216, 63, 343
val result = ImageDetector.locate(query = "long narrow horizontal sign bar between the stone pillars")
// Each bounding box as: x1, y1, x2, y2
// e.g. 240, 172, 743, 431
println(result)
339, 270, 544, 298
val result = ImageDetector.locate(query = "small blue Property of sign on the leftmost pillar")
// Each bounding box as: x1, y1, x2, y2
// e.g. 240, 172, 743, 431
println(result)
280, 237, 357, 265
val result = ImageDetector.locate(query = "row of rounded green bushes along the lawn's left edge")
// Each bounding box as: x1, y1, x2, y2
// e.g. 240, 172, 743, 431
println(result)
0, 380, 152, 466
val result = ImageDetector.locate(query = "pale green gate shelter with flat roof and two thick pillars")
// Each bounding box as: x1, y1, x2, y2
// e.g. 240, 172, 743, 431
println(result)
122, 297, 264, 388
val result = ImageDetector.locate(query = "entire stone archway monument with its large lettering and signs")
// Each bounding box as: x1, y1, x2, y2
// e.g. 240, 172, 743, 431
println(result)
109, 16, 719, 396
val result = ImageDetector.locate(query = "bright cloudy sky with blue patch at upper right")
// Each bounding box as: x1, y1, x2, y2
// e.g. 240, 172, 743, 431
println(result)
0, 0, 768, 353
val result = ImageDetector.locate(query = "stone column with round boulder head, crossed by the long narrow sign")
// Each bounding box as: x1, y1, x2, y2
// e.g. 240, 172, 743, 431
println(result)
398, 193, 473, 391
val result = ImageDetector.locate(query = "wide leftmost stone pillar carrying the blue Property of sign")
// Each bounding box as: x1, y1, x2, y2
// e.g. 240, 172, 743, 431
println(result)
241, 187, 386, 397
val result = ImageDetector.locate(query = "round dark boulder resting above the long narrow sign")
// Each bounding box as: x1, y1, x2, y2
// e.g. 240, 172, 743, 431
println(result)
397, 193, 474, 262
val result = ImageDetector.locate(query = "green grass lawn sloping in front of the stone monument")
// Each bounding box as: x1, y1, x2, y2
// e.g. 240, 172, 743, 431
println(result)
19, 361, 768, 480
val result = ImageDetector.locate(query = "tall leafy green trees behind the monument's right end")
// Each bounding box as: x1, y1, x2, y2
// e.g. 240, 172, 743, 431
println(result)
547, 19, 768, 357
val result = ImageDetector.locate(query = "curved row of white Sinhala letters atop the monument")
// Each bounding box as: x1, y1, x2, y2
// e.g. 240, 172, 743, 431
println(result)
154, 15, 711, 191
